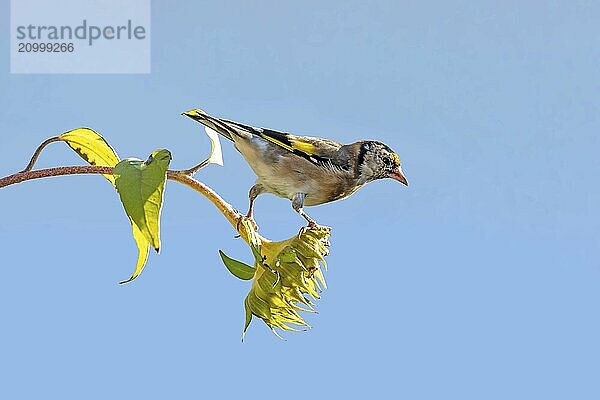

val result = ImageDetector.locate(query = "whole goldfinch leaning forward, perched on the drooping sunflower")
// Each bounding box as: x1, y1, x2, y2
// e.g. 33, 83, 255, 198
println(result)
183, 110, 408, 227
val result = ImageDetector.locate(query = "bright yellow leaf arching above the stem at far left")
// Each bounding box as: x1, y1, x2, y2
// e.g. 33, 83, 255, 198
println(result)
59, 128, 120, 185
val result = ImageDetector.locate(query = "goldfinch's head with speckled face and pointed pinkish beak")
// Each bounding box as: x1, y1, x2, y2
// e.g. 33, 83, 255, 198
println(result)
358, 141, 408, 186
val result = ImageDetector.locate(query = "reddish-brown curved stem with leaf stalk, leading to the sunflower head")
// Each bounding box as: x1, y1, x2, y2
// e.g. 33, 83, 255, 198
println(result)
0, 165, 249, 242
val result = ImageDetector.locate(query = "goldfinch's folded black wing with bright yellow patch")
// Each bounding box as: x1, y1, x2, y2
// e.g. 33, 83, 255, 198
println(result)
222, 120, 350, 169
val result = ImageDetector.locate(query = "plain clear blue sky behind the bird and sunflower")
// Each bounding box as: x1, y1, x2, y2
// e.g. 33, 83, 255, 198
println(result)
0, 0, 600, 399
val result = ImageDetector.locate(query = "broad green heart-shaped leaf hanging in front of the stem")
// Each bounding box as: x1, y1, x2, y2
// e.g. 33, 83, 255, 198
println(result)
114, 149, 171, 252
